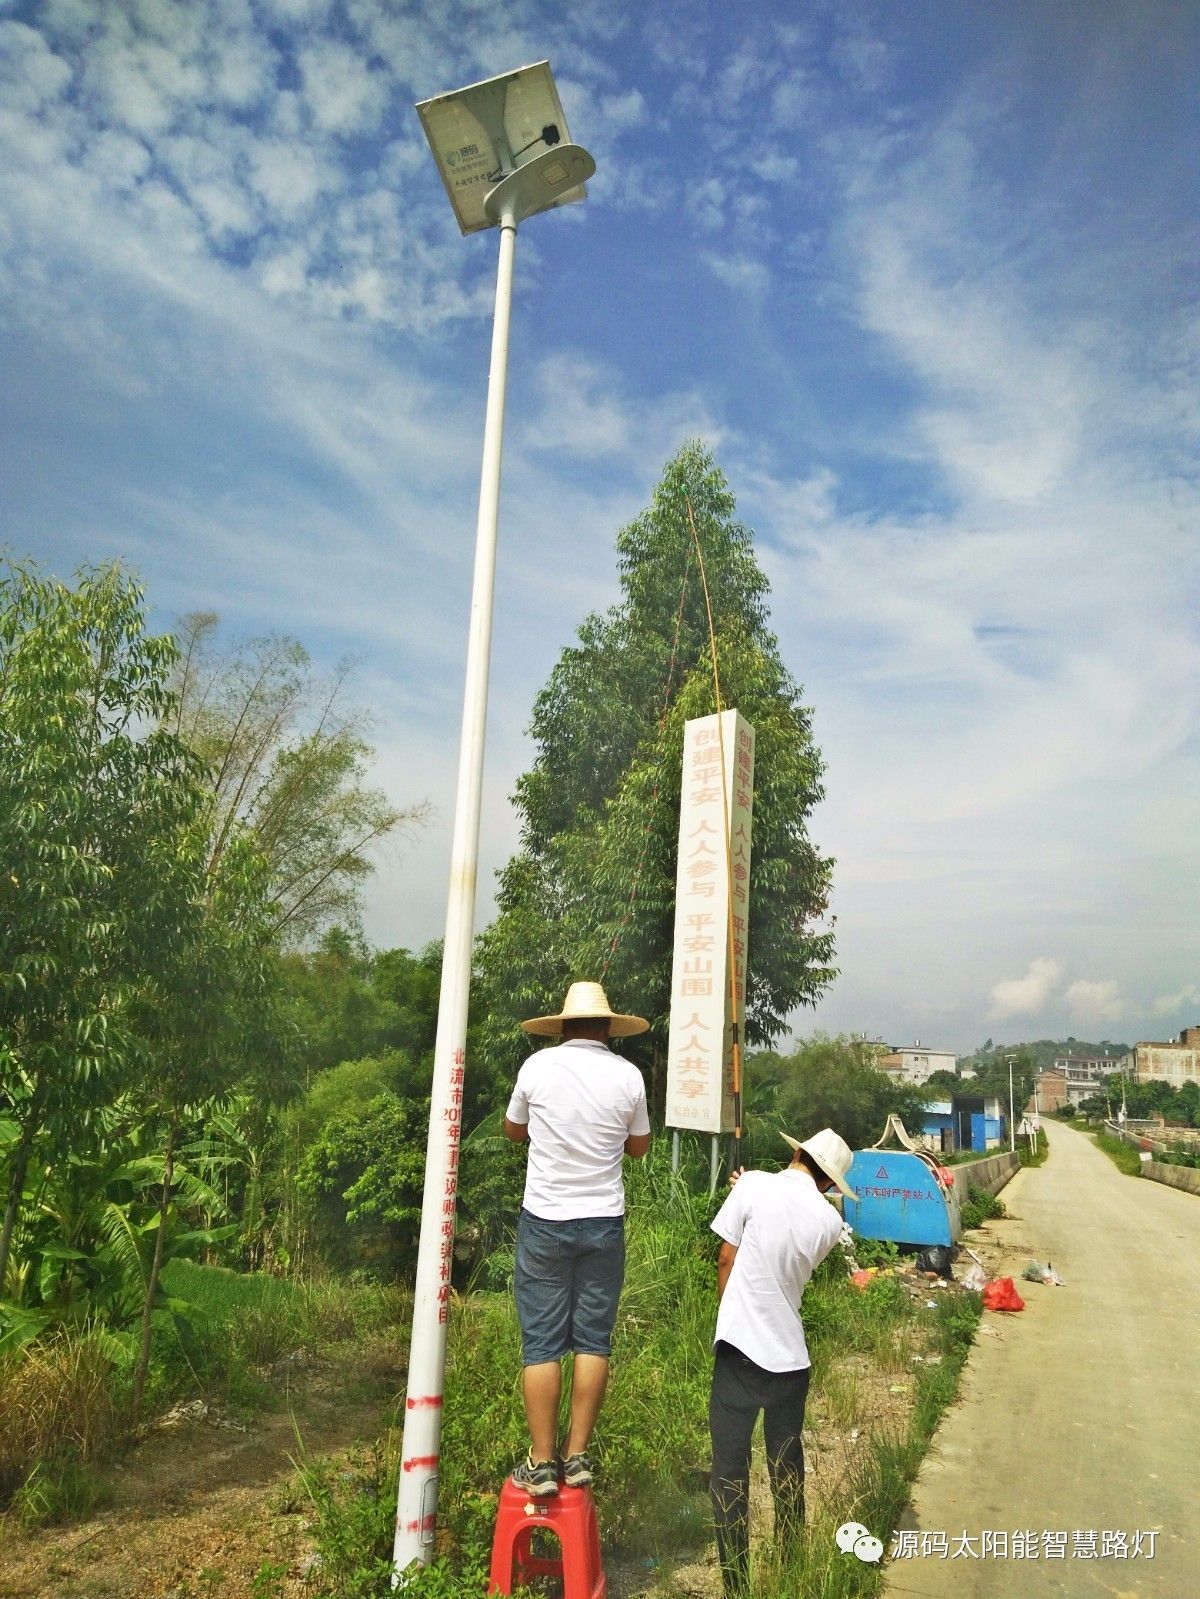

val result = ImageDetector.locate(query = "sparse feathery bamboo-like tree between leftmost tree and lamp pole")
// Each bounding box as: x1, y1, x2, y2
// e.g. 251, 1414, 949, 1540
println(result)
171, 612, 427, 943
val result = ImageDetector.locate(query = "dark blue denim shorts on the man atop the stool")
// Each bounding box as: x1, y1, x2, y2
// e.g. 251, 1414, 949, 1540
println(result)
514, 1210, 626, 1366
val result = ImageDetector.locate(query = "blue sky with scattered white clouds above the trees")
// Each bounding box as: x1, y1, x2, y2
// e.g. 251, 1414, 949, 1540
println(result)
0, 0, 1200, 1049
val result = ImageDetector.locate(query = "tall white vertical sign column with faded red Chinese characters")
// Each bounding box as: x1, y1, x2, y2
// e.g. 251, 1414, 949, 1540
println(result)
666, 710, 754, 1132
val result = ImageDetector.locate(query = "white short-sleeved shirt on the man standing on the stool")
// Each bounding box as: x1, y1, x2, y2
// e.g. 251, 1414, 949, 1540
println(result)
506, 1038, 650, 1222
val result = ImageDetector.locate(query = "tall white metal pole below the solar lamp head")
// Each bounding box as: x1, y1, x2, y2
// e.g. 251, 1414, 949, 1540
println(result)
392, 211, 517, 1586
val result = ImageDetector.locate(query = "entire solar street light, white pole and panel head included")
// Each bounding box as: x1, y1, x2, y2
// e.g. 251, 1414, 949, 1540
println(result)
392, 61, 595, 1585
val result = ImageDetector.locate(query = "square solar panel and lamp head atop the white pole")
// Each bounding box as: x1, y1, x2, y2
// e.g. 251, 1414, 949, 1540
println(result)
416, 61, 595, 233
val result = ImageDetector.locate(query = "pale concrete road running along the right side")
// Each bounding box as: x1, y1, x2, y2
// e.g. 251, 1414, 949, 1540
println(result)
883, 1122, 1200, 1599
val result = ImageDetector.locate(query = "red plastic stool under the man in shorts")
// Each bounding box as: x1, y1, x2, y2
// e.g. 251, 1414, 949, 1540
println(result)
488, 1477, 608, 1599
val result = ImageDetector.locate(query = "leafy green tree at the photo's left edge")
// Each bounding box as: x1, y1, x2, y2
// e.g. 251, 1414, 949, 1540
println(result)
0, 566, 202, 1290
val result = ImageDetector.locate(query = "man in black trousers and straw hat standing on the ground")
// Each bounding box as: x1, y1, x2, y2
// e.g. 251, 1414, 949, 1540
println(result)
709, 1127, 854, 1596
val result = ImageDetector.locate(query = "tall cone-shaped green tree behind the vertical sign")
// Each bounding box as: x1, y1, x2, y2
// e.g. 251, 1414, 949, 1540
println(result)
478, 445, 834, 1099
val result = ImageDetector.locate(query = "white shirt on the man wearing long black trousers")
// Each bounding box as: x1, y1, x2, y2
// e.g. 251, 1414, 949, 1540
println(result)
712, 1166, 842, 1372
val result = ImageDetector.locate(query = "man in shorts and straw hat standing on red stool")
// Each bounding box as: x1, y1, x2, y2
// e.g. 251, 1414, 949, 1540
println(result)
504, 982, 650, 1497
